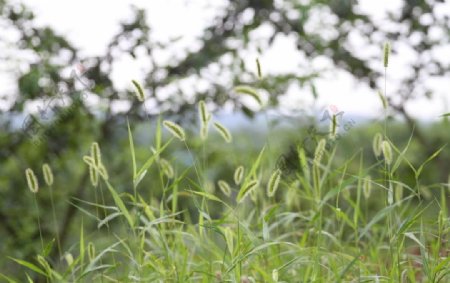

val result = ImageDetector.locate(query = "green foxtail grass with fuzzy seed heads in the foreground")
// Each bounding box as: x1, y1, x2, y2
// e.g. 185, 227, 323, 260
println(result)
0, 52, 450, 282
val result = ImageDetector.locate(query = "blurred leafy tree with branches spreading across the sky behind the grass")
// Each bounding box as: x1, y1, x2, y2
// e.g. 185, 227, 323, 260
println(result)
0, 0, 450, 280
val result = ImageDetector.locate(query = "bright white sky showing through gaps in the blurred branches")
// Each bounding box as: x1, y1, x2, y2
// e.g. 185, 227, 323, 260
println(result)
0, 0, 450, 120
